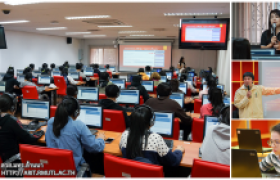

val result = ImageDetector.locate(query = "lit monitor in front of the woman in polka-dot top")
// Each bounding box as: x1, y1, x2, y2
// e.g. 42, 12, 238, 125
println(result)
150, 112, 174, 137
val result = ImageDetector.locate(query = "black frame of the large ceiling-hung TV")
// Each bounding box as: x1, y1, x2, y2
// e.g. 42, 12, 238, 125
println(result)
178, 18, 230, 50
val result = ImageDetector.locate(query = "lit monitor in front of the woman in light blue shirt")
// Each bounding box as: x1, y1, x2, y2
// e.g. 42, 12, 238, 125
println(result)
78, 104, 103, 129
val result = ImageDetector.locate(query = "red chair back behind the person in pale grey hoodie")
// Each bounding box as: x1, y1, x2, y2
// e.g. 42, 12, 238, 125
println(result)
191, 159, 230, 178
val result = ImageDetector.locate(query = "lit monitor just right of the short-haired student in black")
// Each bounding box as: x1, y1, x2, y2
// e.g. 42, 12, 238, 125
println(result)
117, 89, 140, 105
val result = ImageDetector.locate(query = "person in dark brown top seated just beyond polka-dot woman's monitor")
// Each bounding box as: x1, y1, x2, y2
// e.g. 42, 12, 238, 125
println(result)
145, 83, 192, 140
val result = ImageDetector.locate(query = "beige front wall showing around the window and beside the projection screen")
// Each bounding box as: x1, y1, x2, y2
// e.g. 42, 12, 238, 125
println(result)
83, 39, 217, 72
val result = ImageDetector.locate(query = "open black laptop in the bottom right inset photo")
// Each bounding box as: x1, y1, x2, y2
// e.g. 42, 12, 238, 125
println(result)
236, 129, 271, 153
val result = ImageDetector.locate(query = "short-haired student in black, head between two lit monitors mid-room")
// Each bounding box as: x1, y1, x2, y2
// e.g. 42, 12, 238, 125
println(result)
98, 84, 130, 128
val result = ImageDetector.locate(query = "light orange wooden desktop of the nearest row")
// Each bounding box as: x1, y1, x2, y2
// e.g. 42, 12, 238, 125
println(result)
20, 120, 201, 167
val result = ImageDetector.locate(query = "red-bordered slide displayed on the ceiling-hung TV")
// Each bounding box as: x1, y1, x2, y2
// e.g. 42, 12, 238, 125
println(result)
181, 24, 227, 43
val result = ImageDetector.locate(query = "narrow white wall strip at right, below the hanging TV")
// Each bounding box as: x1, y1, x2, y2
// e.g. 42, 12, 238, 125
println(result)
216, 41, 231, 95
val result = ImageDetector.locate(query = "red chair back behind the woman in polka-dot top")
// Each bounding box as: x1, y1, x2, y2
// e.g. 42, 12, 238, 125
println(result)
104, 153, 164, 177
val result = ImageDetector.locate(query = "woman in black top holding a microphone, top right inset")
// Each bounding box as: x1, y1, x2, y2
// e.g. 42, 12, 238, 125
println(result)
261, 9, 280, 49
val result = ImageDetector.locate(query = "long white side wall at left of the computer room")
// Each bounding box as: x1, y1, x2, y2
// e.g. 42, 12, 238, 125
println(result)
0, 31, 84, 72
